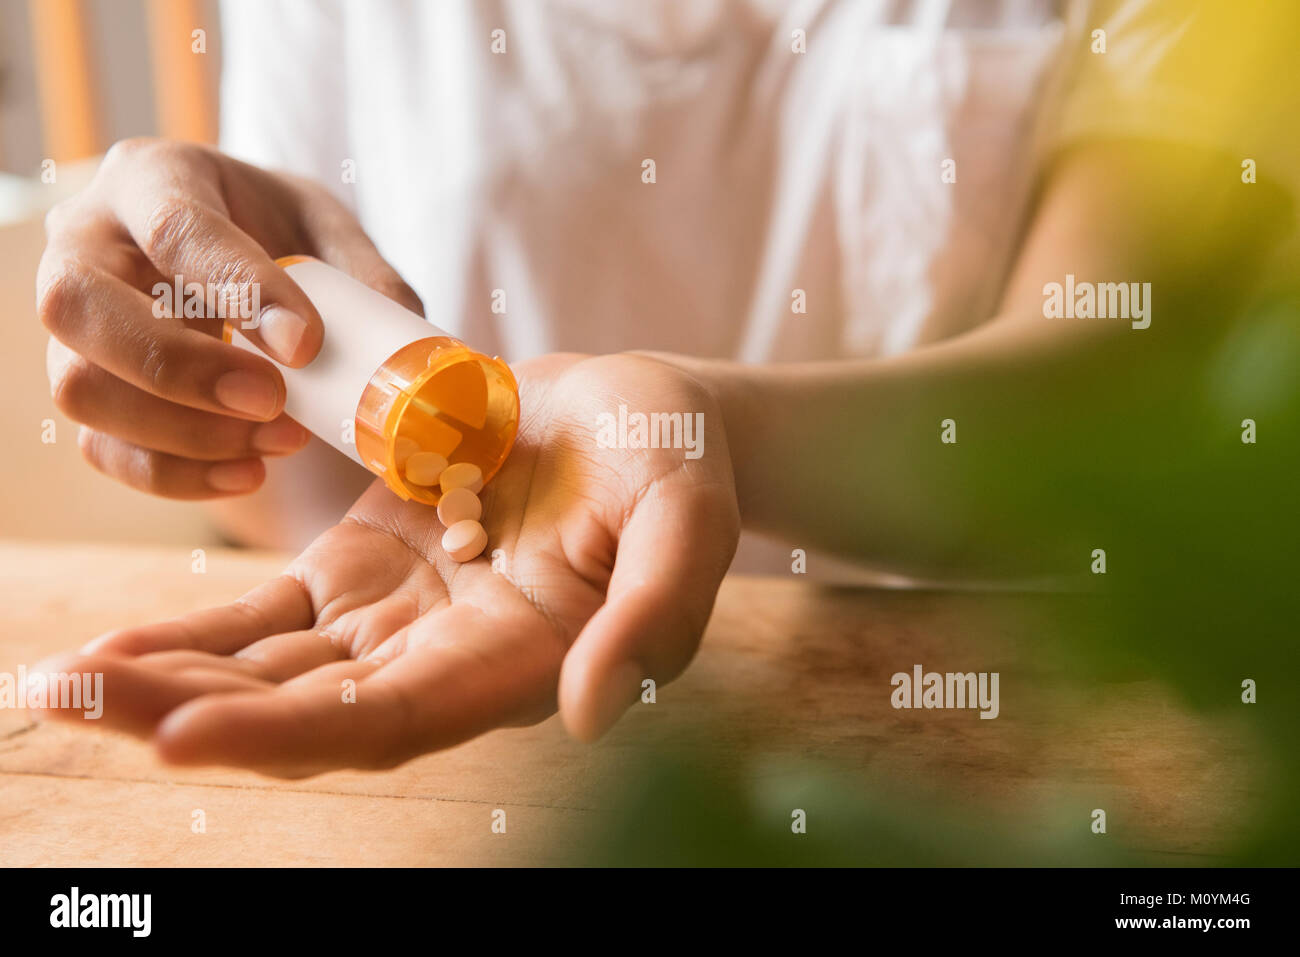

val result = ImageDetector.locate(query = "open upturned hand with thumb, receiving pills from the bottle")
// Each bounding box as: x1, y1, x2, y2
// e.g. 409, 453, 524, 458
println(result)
42, 355, 738, 776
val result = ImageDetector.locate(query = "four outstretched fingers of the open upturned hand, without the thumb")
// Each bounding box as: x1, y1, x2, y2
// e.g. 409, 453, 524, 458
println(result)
39, 581, 563, 778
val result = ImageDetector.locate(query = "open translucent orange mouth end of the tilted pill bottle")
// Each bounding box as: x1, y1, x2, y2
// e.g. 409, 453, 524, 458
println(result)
355, 335, 519, 506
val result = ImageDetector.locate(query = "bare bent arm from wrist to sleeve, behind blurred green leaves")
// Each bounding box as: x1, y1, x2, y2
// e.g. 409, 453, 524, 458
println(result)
670, 146, 1290, 576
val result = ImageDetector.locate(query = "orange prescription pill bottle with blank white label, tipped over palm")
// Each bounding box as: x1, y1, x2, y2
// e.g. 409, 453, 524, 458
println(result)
225, 256, 519, 505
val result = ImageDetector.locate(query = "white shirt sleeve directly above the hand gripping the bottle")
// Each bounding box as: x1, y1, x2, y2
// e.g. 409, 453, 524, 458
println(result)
221, 0, 354, 207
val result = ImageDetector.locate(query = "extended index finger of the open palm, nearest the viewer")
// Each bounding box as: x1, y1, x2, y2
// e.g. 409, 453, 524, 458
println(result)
155, 605, 562, 778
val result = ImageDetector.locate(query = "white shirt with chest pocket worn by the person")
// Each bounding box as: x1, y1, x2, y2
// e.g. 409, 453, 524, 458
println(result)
221, 0, 1289, 579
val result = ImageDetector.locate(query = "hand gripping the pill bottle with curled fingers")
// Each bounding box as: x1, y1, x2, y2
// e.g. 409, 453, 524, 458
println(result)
36, 139, 421, 509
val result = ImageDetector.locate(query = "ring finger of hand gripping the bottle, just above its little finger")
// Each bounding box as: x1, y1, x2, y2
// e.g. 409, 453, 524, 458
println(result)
46, 338, 311, 462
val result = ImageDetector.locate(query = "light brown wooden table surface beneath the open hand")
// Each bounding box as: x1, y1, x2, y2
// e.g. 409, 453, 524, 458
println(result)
0, 542, 1257, 866
